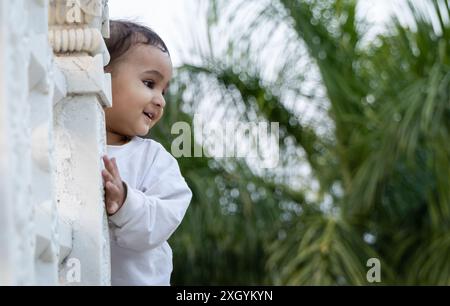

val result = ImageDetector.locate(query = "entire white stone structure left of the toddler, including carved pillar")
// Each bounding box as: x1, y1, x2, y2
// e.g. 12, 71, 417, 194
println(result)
0, 0, 111, 285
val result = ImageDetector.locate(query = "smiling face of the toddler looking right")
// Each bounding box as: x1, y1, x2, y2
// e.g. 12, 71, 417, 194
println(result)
105, 44, 172, 139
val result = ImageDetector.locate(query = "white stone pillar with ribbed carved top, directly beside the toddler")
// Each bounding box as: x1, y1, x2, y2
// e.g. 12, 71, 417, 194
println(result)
49, 0, 111, 285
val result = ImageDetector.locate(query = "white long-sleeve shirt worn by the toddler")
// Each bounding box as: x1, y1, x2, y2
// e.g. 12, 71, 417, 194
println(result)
107, 137, 192, 285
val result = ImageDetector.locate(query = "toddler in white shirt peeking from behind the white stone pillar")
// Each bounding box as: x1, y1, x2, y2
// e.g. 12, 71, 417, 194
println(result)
102, 21, 192, 285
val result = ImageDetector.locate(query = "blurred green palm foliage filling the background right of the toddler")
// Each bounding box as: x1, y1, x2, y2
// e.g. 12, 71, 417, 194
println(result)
152, 0, 450, 285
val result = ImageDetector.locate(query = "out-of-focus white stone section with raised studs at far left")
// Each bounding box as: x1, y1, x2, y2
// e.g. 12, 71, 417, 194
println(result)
0, 0, 76, 285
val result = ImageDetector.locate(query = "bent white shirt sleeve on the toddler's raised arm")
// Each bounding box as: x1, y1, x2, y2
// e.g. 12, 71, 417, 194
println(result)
109, 149, 192, 251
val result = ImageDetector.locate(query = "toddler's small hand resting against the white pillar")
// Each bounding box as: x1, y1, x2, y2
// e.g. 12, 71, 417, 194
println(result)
102, 155, 127, 215
